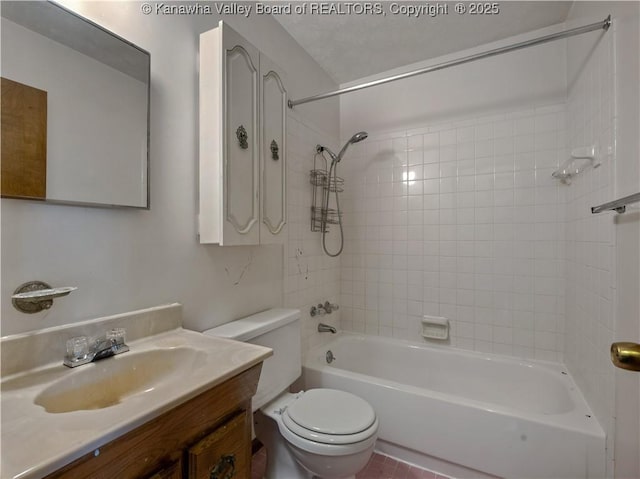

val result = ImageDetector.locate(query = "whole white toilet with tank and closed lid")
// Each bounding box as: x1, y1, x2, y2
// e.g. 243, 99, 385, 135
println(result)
205, 309, 378, 479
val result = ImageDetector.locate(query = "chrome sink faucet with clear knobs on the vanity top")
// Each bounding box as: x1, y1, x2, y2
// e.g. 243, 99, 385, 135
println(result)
63, 328, 129, 368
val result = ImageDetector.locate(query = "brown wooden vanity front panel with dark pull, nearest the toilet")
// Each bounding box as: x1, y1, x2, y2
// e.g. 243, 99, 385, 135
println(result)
187, 411, 251, 479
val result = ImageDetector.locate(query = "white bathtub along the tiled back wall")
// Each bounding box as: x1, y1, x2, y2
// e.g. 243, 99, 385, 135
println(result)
303, 333, 605, 479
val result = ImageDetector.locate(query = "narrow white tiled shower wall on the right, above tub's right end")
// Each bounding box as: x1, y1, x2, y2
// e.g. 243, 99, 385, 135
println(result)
564, 18, 616, 477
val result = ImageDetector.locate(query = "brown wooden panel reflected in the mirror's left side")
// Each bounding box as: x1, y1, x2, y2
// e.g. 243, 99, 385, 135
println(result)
0, 78, 47, 199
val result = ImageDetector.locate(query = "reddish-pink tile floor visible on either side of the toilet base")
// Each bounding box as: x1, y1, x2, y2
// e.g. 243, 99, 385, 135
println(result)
251, 448, 448, 479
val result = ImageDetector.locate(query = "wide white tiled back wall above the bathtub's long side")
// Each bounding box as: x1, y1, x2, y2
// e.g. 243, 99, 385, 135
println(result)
339, 104, 566, 360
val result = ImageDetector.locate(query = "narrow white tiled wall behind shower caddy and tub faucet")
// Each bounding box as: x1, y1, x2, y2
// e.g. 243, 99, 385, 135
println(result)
284, 111, 341, 354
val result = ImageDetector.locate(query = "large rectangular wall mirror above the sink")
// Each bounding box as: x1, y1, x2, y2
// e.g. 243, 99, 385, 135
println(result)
0, 1, 150, 208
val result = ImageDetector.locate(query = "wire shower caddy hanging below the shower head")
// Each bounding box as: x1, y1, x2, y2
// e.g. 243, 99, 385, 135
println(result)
309, 147, 344, 233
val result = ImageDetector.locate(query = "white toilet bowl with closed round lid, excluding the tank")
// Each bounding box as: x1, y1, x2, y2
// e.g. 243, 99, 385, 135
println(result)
255, 389, 378, 479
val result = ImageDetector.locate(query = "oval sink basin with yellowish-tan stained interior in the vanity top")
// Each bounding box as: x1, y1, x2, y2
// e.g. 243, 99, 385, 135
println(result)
34, 347, 205, 413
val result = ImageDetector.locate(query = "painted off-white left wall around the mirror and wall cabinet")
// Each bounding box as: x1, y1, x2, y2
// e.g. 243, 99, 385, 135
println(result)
0, 1, 338, 348
